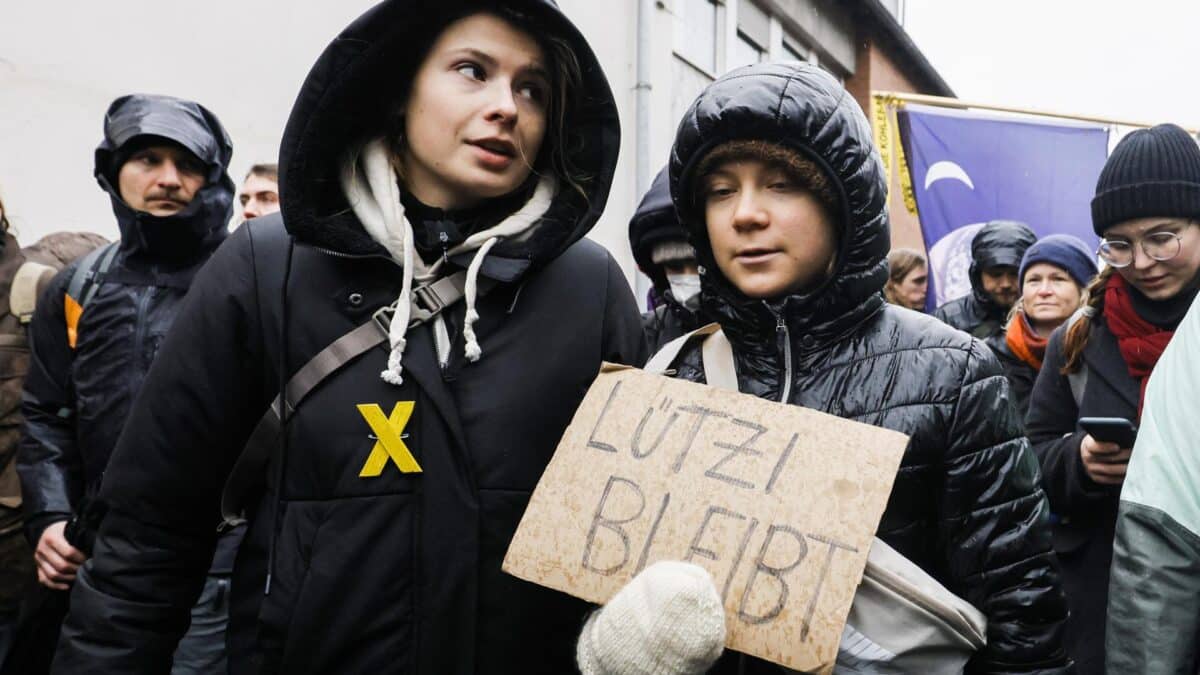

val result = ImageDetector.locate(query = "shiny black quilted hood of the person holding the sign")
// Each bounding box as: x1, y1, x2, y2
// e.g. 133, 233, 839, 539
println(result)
671, 64, 890, 348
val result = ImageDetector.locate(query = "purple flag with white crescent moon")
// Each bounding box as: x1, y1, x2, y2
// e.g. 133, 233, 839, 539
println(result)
898, 104, 1109, 309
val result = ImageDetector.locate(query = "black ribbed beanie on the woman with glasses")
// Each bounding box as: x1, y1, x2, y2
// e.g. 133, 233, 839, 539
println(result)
1092, 124, 1200, 237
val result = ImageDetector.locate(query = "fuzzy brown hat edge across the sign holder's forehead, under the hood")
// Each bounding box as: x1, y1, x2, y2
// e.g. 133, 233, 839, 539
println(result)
690, 141, 844, 223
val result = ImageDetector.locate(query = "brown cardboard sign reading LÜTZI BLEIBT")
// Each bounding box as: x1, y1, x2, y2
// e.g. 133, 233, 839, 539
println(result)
504, 364, 908, 670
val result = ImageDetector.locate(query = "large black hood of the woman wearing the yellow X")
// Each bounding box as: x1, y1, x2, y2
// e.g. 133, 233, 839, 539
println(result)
280, 0, 620, 273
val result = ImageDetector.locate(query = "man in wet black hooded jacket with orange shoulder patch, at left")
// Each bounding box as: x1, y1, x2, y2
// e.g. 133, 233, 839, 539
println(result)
15, 95, 236, 673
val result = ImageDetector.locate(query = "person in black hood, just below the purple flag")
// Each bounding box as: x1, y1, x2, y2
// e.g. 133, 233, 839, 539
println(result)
934, 220, 1038, 340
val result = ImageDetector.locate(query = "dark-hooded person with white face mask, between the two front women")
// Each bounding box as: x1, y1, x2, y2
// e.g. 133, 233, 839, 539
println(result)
629, 167, 707, 352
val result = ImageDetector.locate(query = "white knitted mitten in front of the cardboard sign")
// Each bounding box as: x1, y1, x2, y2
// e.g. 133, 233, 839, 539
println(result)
575, 561, 725, 675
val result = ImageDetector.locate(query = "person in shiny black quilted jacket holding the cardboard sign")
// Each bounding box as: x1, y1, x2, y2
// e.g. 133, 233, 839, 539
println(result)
671, 64, 1069, 673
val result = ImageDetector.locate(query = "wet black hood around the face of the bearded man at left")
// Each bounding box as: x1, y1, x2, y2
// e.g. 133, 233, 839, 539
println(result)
94, 94, 234, 262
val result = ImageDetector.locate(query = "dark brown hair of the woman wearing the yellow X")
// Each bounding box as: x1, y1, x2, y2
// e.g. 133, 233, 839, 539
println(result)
386, 7, 592, 201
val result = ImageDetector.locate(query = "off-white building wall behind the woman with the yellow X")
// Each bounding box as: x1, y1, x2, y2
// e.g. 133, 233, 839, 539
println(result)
0, 0, 676, 285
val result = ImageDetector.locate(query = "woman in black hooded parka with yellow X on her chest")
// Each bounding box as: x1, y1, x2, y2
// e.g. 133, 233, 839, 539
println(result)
55, 0, 646, 674
